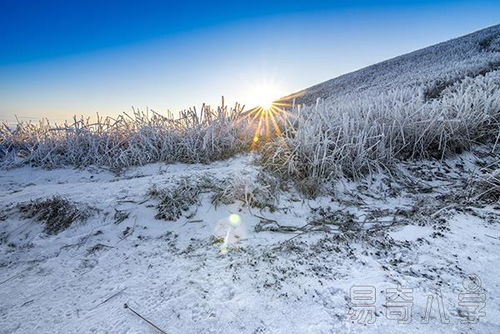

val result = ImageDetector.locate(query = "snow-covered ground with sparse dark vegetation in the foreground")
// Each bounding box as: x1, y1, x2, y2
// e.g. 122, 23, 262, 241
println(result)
0, 147, 500, 334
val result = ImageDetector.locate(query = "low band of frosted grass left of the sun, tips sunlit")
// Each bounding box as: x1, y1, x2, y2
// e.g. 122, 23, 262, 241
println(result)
0, 101, 248, 169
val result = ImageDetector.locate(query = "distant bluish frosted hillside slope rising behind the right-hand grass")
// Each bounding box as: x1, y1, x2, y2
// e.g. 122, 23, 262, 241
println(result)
283, 25, 500, 104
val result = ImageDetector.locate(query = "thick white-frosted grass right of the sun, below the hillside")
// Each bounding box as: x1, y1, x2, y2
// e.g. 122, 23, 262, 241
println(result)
262, 71, 500, 184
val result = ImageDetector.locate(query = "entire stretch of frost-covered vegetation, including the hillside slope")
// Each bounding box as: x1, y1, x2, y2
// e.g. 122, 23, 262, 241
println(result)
0, 26, 500, 190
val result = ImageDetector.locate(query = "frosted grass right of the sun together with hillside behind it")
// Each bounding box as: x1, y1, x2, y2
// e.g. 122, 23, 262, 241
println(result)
263, 25, 500, 187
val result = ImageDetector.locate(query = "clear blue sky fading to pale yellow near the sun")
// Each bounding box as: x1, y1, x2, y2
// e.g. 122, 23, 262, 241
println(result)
0, 0, 500, 122
